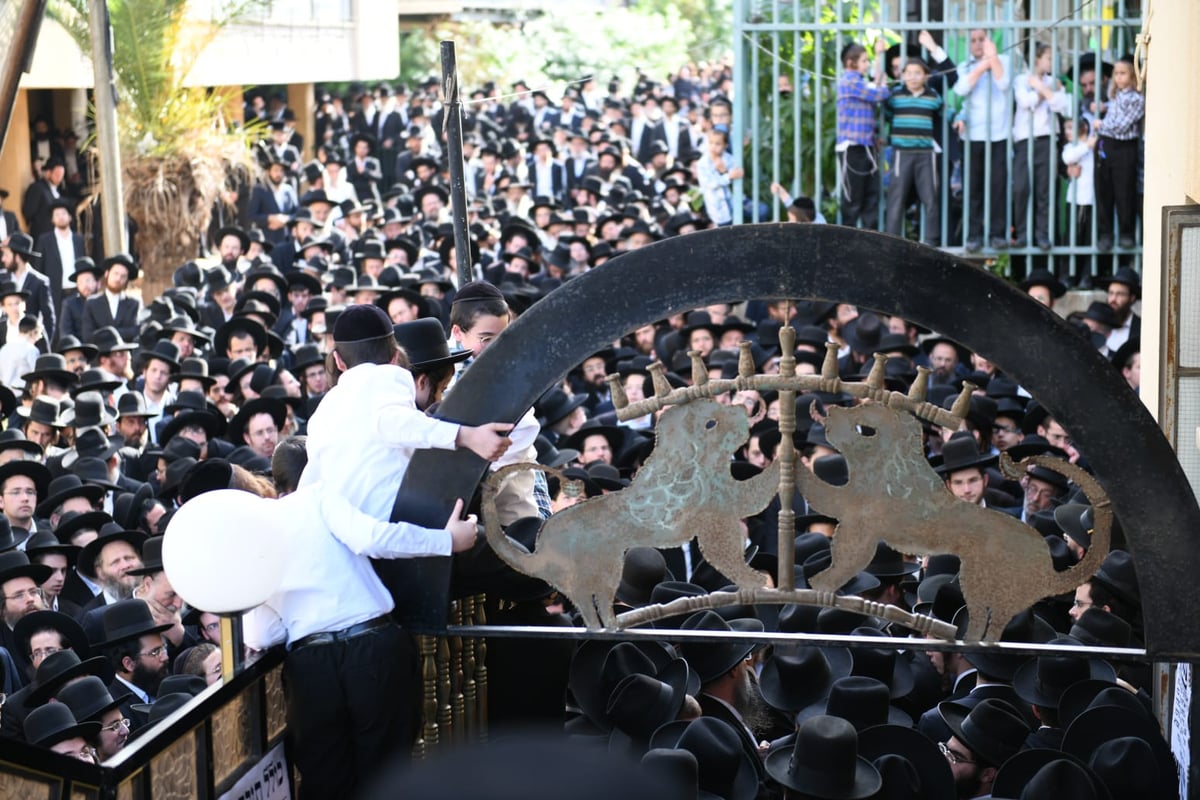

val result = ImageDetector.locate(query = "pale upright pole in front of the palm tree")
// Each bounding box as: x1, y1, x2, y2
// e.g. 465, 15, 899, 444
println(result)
88, 0, 130, 257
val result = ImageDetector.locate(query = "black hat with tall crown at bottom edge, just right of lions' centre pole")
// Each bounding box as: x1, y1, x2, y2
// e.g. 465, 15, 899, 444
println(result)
766, 715, 883, 800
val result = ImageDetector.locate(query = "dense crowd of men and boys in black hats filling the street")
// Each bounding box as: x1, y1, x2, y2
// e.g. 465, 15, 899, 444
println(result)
0, 32, 1176, 800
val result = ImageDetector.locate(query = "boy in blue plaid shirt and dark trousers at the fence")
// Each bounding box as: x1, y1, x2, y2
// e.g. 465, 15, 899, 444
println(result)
838, 38, 888, 230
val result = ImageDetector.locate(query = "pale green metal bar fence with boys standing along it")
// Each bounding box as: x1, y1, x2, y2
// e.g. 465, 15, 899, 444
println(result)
732, 0, 1141, 279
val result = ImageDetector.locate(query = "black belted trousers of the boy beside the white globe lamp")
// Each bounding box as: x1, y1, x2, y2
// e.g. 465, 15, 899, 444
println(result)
283, 625, 420, 800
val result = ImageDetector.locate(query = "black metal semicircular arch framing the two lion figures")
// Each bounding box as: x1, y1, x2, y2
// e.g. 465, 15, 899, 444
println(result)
379, 223, 1200, 660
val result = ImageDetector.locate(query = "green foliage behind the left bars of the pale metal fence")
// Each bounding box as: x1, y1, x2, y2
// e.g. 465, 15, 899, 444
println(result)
743, 0, 883, 212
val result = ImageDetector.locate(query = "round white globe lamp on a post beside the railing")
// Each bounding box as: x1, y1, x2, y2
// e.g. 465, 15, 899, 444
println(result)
162, 489, 287, 614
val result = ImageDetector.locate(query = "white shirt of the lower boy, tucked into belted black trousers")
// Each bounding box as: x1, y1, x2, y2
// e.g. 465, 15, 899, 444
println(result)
242, 484, 451, 650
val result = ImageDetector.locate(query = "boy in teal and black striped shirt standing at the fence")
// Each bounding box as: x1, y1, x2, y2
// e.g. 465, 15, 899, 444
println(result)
886, 59, 942, 247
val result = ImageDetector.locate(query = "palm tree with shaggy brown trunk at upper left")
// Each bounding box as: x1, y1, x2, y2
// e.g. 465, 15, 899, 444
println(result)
49, 0, 269, 296
